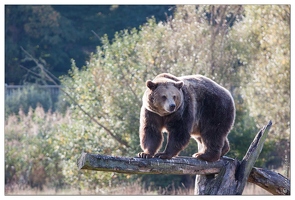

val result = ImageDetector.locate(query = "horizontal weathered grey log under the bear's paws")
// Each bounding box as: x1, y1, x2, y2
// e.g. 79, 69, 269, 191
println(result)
77, 152, 232, 175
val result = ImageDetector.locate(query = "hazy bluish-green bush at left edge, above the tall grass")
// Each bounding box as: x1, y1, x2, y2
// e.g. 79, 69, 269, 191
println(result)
5, 85, 53, 117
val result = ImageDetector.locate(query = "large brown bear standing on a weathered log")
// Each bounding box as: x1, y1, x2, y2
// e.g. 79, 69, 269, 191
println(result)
138, 73, 235, 161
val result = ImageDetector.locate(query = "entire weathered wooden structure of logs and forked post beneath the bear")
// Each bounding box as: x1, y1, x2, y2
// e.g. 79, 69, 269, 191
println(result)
77, 122, 290, 195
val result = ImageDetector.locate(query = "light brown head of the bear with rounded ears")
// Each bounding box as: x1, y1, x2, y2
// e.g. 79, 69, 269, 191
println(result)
143, 80, 183, 116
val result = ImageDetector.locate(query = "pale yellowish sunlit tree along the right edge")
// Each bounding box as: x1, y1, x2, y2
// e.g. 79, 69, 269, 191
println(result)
238, 5, 291, 169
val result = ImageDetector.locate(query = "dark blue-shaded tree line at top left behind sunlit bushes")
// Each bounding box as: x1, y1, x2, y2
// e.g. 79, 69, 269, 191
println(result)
5, 5, 174, 84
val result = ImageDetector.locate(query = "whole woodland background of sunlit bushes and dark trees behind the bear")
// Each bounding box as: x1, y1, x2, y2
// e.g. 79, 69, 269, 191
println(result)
4, 5, 291, 194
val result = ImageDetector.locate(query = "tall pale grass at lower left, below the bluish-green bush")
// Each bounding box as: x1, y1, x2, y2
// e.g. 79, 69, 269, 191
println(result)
4, 105, 71, 190
